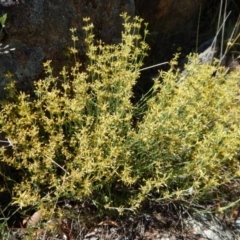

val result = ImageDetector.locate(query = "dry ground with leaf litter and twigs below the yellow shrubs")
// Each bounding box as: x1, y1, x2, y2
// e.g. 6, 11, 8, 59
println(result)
8, 202, 240, 240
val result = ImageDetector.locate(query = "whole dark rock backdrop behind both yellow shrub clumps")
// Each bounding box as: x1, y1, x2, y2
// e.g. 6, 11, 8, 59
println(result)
0, 0, 236, 95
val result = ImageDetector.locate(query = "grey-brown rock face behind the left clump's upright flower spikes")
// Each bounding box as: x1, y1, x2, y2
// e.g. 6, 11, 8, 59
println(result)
0, 0, 135, 93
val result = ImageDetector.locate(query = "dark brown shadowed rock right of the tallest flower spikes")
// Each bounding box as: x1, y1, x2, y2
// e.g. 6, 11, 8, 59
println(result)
135, 0, 210, 65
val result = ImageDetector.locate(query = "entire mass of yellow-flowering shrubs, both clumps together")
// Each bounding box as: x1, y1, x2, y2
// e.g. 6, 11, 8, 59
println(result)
0, 15, 240, 215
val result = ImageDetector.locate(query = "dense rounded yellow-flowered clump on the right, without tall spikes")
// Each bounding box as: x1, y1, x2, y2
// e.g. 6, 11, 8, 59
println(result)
133, 56, 240, 204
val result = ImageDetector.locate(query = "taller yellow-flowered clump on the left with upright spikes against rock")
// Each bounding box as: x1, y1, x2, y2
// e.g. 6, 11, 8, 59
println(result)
0, 14, 148, 216
